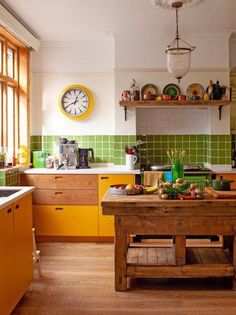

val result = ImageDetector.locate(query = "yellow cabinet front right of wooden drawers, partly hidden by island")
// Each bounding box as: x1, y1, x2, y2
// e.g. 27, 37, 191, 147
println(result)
98, 174, 135, 236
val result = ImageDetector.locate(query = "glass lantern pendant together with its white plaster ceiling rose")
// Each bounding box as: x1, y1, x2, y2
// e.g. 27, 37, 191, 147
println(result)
152, 0, 203, 82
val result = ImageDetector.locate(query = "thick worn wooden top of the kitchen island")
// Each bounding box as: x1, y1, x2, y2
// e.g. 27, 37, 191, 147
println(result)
101, 192, 236, 216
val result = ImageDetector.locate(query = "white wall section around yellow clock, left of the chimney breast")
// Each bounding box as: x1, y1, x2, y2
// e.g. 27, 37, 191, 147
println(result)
31, 42, 115, 135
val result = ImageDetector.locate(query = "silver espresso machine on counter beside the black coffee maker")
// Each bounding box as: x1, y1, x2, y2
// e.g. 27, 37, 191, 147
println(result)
57, 141, 78, 169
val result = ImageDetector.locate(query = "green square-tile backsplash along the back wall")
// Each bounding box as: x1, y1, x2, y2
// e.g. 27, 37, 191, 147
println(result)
31, 135, 231, 165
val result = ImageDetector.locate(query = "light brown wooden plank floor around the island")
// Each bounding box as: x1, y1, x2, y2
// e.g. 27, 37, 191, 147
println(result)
13, 243, 236, 315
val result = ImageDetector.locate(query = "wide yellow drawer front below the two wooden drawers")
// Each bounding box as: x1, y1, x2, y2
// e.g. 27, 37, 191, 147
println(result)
33, 205, 98, 236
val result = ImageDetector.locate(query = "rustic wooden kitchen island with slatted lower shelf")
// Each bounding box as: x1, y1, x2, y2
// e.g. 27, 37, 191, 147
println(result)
102, 192, 236, 291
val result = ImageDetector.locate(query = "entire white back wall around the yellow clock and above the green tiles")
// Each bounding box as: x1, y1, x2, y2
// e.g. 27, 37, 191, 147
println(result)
31, 32, 230, 135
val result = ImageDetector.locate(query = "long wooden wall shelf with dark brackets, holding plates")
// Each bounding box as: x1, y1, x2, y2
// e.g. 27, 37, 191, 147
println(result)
119, 100, 230, 121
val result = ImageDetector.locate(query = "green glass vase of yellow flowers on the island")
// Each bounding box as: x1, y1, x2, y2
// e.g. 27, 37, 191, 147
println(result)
167, 149, 186, 182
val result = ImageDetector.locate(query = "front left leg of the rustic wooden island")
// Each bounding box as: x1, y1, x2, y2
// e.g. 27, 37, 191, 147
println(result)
115, 216, 128, 291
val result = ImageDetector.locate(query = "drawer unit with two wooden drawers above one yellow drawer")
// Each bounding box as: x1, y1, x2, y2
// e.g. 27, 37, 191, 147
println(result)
21, 174, 98, 237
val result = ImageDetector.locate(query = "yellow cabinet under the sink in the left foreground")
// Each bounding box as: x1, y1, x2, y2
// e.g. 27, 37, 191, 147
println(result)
0, 194, 33, 315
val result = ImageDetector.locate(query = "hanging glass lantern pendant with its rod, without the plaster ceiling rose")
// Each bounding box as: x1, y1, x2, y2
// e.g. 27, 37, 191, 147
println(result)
165, 1, 195, 82
